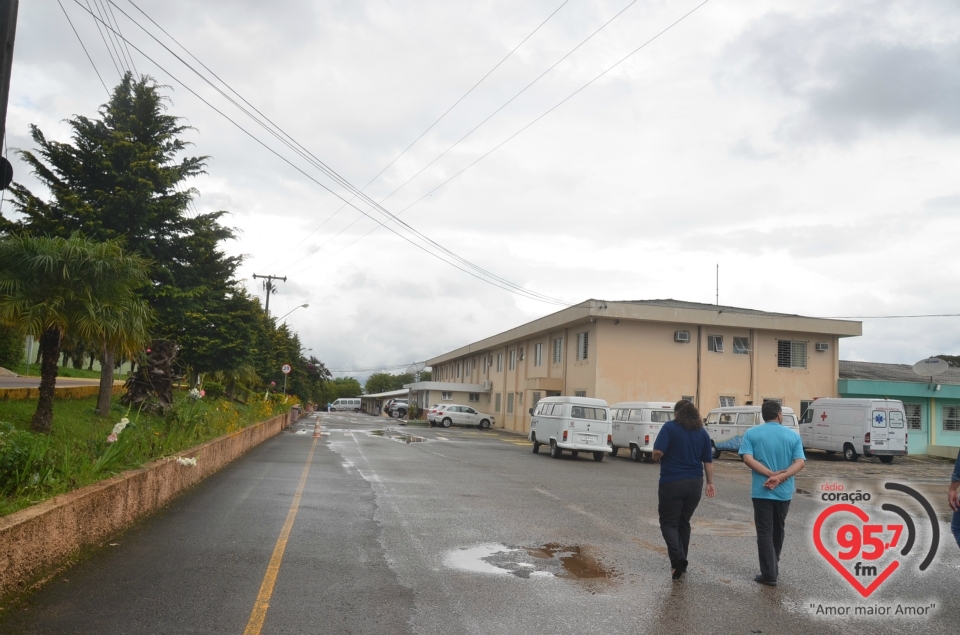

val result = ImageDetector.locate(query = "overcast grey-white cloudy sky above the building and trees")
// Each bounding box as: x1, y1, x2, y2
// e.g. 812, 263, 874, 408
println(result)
4, 0, 960, 376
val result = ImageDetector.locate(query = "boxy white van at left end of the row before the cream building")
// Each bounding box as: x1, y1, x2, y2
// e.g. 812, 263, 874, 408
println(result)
527, 397, 612, 461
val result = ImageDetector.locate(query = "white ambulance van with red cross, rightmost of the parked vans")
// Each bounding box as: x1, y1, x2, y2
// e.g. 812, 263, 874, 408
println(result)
800, 399, 907, 463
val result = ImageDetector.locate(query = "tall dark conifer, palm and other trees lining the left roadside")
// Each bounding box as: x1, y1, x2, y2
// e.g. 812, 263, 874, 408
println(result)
0, 73, 334, 431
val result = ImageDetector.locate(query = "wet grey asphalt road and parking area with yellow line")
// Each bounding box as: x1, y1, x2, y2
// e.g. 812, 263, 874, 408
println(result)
0, 414, 960, 635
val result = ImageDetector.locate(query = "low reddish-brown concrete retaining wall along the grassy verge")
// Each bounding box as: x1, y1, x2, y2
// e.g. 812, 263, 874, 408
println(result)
0, 414, 290, 598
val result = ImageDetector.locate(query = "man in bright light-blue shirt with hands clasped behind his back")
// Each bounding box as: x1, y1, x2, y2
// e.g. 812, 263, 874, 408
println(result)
740, 401, 806, 586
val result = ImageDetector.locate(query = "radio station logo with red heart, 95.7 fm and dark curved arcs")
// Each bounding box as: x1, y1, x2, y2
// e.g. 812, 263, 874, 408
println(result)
813, 483, 940, 598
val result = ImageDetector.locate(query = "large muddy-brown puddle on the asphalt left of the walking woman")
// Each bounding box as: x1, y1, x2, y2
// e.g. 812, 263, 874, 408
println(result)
444, 543, 617, 580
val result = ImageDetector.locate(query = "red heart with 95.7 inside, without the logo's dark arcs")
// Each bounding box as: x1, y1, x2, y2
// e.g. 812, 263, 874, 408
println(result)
813, 503, 912, 598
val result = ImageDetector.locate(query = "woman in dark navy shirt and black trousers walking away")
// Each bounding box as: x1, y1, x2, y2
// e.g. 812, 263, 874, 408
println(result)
653, 400, 716, 580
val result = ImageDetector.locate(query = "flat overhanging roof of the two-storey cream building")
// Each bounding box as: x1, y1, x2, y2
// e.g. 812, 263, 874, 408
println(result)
427, 298, 863, 366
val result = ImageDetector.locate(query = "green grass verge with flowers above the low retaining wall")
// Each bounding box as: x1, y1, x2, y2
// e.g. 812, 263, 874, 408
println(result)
0, 393, 288, 516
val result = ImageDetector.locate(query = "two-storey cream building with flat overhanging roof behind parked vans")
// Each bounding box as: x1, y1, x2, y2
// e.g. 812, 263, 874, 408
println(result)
420, 300, 862, 432
